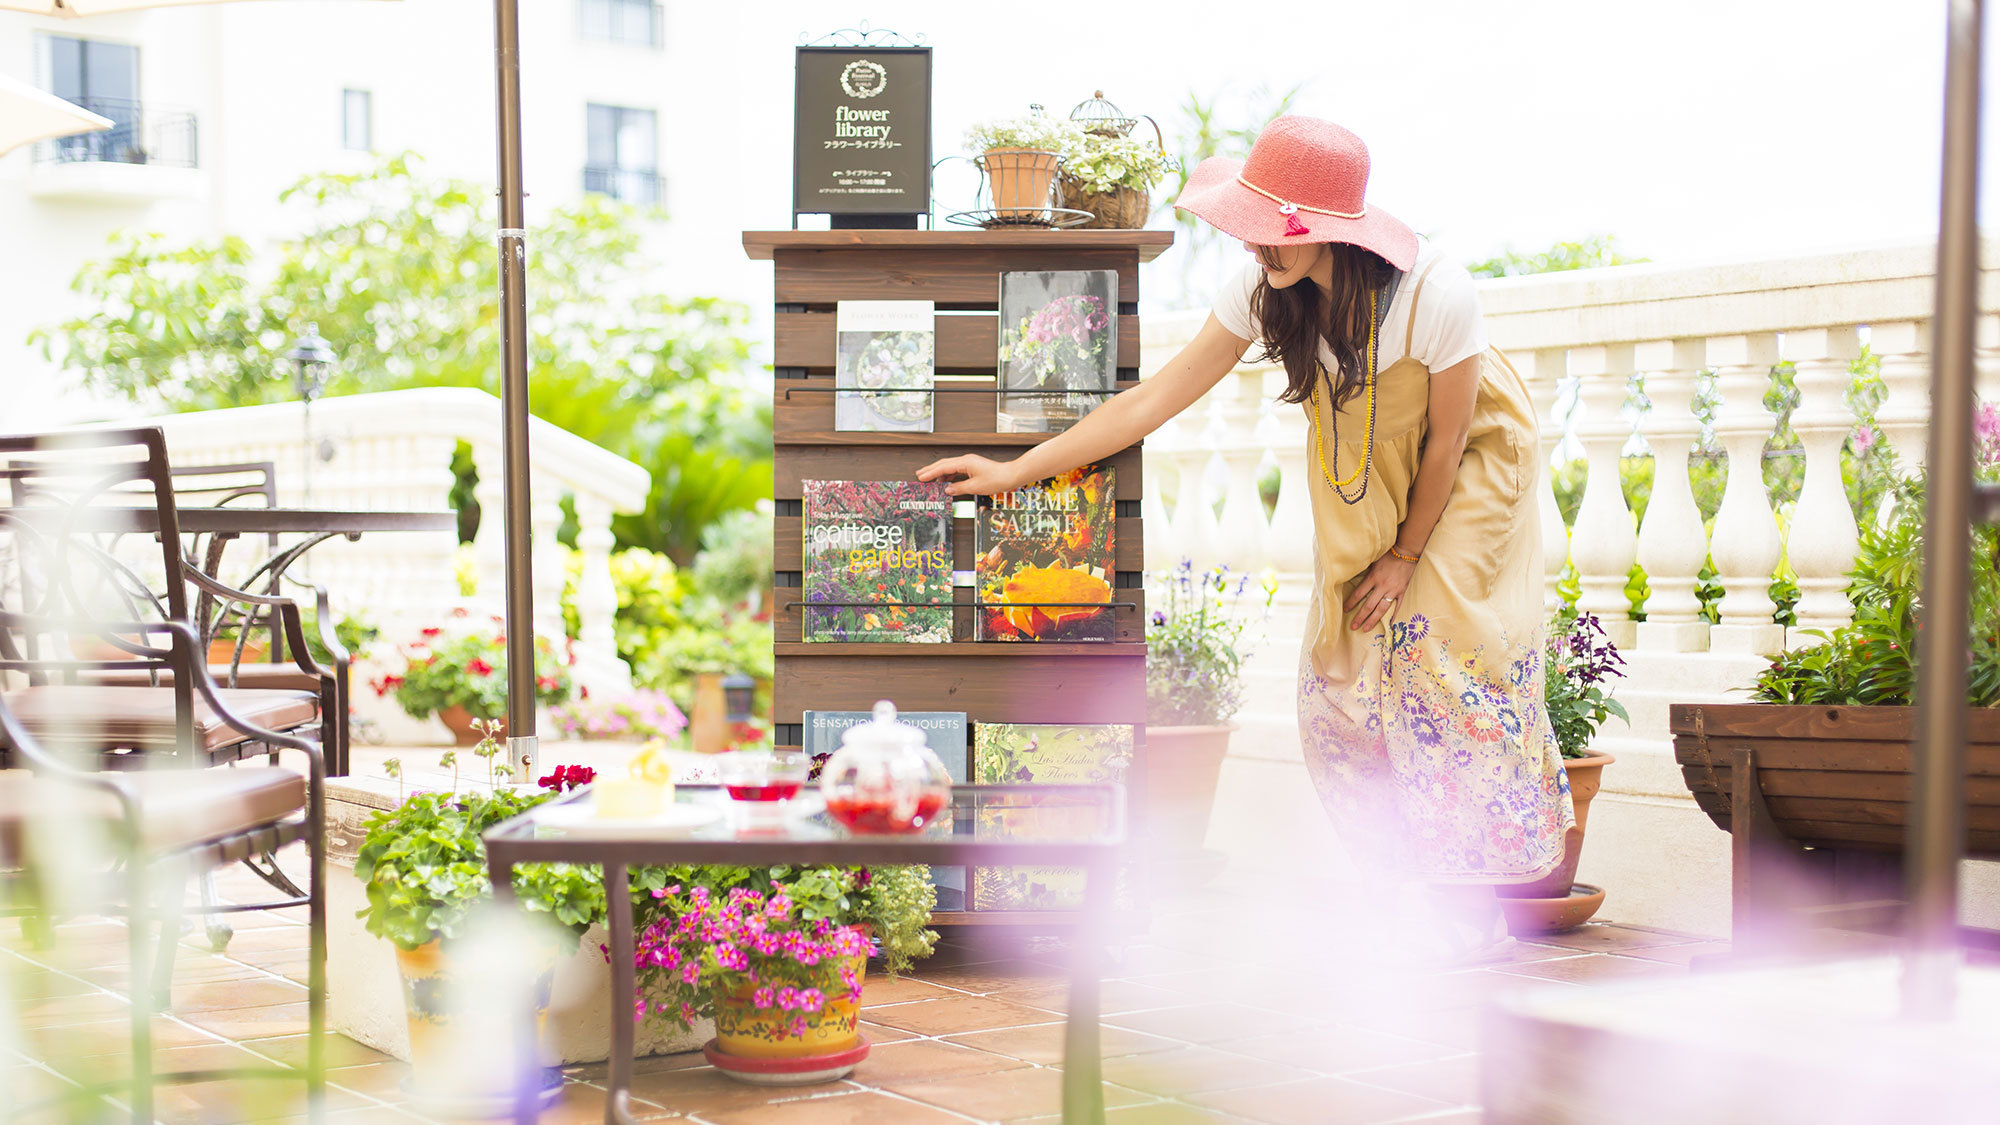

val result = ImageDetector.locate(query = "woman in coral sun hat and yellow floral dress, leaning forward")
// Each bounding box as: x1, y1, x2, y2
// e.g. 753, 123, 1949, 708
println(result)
918, 116, 1574, 961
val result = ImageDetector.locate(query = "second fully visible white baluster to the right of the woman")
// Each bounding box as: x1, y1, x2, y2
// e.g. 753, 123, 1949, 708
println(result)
1632, 340, 1708, 653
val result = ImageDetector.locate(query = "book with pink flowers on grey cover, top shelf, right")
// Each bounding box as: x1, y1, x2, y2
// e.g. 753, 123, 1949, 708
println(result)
994, 270, 1118, 434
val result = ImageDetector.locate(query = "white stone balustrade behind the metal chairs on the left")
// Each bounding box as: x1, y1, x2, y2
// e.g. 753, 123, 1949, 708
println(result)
142, 386, 650, 691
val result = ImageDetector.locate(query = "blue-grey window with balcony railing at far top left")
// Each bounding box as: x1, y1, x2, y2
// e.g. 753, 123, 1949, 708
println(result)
36, 34, 196, 168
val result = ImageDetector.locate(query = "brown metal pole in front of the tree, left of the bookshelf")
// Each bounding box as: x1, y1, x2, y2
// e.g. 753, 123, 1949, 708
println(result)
494, 0, 540, 768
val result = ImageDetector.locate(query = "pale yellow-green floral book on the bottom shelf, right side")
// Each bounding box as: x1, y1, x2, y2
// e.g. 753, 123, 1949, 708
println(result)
972, 723, 1132, 911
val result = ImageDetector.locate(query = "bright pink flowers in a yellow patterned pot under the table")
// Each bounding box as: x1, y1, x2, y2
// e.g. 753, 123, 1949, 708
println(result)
634, 867, 938, 1085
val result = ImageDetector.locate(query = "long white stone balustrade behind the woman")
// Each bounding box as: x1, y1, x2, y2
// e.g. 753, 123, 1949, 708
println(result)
1144, 242, 2000, 655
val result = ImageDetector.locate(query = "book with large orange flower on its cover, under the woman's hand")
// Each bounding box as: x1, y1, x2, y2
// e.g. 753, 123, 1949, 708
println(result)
972, 464, 1118, 641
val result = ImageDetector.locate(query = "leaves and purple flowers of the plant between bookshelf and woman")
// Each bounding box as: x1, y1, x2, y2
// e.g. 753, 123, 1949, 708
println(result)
1146, 558, 1278, 727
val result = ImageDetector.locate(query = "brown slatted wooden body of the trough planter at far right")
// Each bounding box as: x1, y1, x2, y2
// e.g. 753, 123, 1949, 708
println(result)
1668, 703, 2000, 857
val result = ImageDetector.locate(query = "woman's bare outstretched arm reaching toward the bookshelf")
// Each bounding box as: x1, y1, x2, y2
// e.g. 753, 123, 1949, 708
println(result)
916, 314, 1250, 496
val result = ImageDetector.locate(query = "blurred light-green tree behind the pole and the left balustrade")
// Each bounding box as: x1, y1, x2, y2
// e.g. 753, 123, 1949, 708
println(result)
45, 154, 770, 560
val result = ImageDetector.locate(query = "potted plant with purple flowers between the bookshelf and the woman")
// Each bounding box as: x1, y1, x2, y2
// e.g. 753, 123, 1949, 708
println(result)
1144, 558, 1276, 861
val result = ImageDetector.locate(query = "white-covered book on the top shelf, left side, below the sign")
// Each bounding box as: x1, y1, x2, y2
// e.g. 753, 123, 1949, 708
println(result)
834, 300, 938, 434
